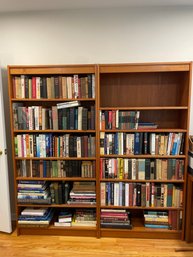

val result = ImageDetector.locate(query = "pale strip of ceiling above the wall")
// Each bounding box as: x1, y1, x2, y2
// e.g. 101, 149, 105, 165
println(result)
0, 0, 193, 13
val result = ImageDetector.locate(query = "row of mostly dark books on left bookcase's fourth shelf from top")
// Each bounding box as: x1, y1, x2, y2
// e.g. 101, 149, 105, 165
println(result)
16, 160, 96, 178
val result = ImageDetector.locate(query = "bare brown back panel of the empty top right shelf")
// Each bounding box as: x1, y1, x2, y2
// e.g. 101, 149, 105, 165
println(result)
100, 72, 189, 107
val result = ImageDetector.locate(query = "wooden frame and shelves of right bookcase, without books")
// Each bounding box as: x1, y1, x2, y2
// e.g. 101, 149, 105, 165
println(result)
98, 63, 192, 239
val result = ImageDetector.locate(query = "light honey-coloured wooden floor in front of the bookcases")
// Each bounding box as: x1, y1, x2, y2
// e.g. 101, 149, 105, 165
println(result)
0, 229, 193, 257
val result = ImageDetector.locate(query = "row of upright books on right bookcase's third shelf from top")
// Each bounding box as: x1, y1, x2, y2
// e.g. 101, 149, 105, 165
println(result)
100, 132, 184, 155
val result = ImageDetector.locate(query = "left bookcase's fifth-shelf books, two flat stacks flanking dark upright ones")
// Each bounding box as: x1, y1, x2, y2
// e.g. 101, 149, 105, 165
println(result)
17, 180, 96, 205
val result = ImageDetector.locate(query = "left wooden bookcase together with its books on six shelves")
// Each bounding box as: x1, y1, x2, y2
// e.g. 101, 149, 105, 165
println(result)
8, 65, 98, 236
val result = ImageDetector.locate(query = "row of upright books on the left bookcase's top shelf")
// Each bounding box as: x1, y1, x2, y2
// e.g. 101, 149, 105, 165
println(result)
12, 74, 95, 99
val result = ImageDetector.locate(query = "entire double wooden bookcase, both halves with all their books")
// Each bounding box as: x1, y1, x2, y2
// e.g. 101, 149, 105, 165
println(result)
8, 62, 191, 239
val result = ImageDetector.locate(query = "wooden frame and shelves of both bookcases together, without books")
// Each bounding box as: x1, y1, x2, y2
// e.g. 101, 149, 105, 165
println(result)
8, 62, 192, 238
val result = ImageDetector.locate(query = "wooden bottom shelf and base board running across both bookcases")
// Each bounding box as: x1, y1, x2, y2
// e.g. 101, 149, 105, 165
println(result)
17, 223, 182, 239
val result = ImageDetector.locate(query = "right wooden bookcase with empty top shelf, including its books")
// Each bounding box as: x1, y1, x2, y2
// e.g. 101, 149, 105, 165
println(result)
98, 63, 191, 239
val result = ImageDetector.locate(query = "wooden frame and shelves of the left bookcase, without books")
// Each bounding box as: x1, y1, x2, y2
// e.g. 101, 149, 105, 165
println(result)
8, 64, 99, 237
